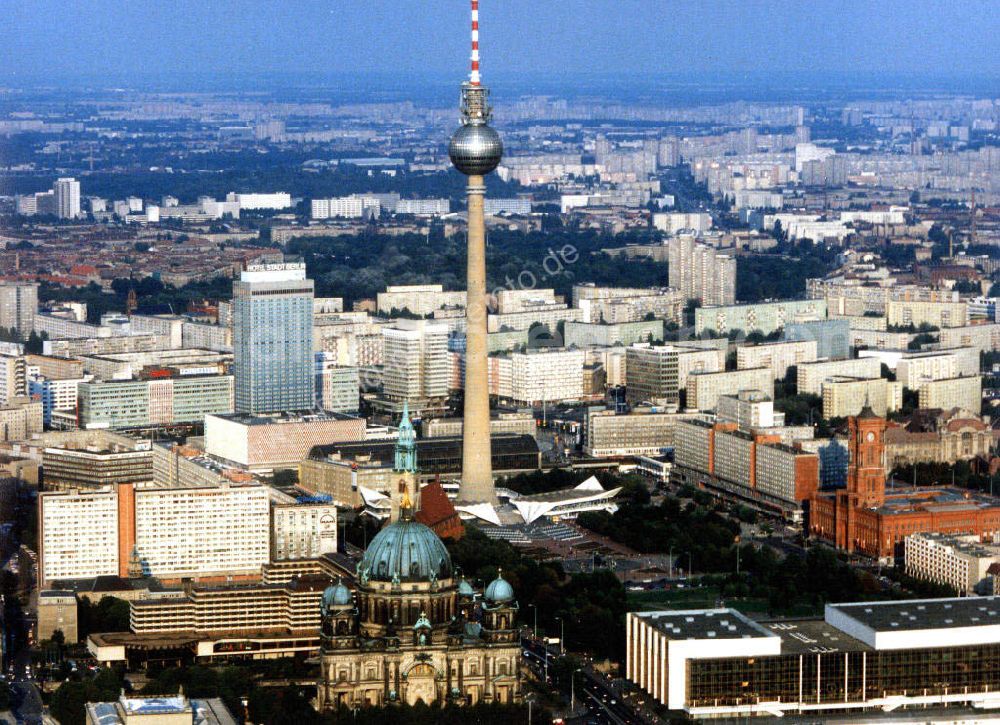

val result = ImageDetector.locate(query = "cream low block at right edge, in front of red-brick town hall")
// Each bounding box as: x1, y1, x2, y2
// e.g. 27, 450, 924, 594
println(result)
903, 533, 1000, 596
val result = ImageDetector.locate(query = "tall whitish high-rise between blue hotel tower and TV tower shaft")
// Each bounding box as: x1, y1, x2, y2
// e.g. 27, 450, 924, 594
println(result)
382, 320, 451, 406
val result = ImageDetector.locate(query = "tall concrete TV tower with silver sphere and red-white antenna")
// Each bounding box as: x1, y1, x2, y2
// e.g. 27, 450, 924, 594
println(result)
448, 0, 503, 505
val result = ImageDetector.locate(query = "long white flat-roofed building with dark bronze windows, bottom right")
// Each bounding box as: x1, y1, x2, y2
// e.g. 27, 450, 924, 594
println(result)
625, 597, 1000, 722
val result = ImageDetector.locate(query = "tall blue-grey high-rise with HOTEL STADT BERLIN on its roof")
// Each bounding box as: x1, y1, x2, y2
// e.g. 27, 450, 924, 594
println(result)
233, 262, 315, 414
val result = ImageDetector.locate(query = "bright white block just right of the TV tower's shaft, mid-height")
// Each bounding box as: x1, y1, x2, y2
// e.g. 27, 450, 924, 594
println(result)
510, 350, 584, 404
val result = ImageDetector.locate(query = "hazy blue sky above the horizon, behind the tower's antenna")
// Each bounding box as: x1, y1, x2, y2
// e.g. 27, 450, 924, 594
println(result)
0, 0, 1000, 83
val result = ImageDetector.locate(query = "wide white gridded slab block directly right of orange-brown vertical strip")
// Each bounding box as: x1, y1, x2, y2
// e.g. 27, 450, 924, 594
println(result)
135, 484, 271, 579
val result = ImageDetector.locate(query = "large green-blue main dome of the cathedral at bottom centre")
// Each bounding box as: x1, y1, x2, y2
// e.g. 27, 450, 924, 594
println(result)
361, 518, 451, 582
